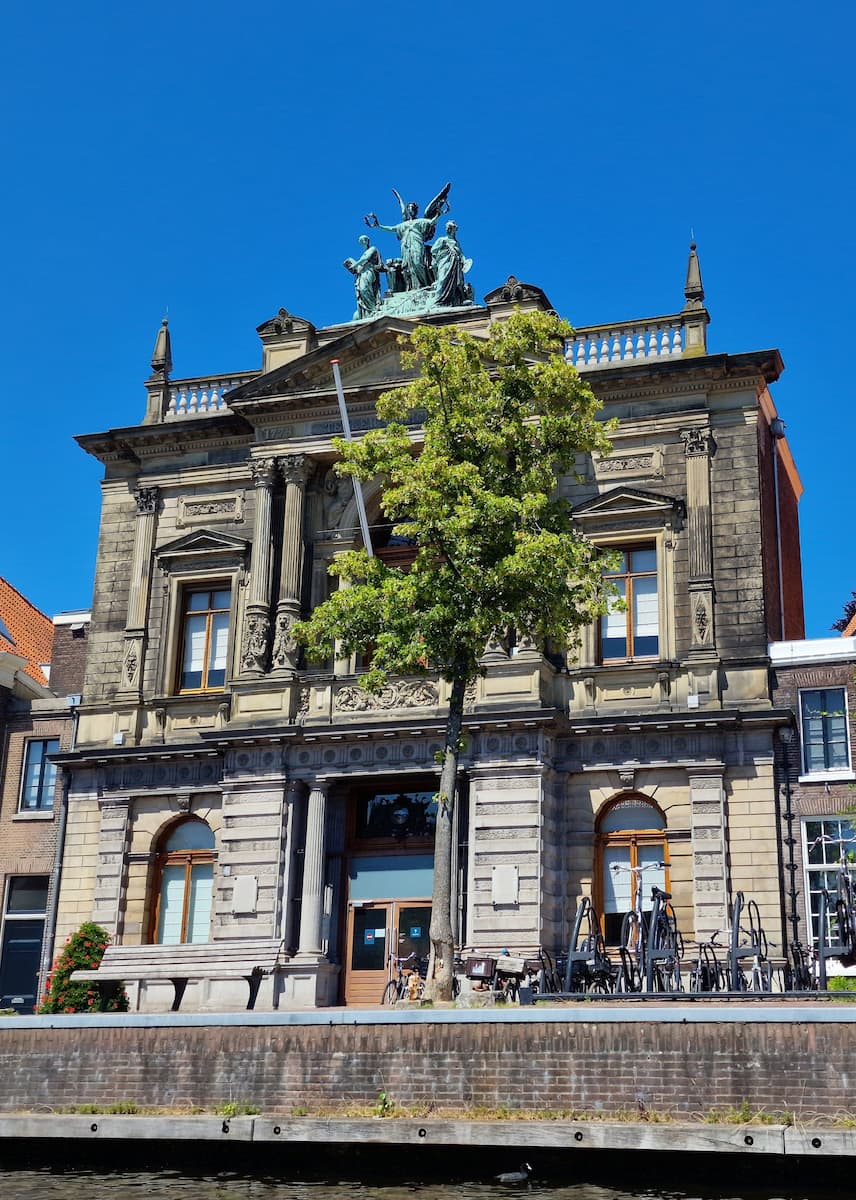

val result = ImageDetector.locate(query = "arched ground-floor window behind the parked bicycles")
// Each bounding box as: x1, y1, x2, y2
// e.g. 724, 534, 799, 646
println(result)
595, 792, 669, 946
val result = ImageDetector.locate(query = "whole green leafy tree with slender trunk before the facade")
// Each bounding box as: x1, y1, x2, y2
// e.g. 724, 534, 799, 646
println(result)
298, 312, 610, 1000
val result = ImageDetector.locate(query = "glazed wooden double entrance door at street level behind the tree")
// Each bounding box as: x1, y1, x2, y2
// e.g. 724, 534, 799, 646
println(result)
345, 900, 431, 1007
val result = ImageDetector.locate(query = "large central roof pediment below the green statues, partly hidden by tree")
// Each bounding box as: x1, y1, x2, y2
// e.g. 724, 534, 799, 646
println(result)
225, 317, 413, 412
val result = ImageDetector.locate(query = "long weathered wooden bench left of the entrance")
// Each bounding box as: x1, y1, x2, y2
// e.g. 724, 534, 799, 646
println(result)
71, 937, 286, 1013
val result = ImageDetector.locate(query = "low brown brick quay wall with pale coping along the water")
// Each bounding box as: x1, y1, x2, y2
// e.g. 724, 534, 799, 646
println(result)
0, 1004, 856, 1121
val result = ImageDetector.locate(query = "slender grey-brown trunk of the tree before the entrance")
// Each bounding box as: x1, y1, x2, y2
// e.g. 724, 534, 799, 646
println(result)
425, 677, 467, 1000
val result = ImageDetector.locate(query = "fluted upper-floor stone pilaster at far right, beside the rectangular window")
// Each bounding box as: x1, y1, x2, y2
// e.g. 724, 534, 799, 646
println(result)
681, 428, 717, 656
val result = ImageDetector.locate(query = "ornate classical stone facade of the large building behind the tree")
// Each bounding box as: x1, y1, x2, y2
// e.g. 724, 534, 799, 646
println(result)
59, 248, 803, 1008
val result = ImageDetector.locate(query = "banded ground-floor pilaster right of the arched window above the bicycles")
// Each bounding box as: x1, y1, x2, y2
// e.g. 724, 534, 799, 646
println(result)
689, 767, 729, 940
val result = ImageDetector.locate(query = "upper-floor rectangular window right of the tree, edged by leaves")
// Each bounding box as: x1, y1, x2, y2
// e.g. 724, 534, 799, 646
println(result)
600, 546, 660, 662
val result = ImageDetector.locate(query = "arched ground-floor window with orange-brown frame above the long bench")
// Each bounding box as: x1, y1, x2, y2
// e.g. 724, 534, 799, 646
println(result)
152, 817, 214, 946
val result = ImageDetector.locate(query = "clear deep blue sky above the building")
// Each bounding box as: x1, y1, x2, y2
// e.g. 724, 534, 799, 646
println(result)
0, 0, 856, 636
